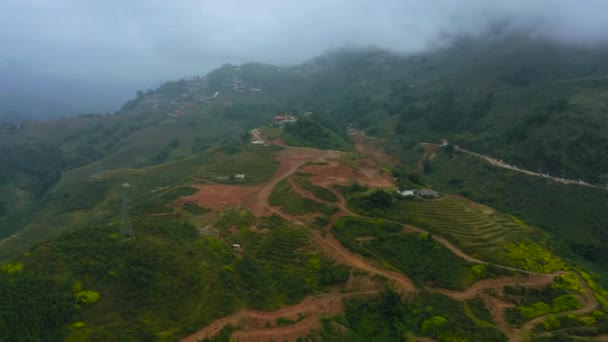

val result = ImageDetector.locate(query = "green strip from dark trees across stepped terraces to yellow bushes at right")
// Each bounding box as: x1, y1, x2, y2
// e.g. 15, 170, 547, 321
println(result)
349, 190, 565, 273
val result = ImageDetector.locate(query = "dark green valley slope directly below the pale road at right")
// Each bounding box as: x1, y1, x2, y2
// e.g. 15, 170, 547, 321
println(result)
426, 150, 608, 273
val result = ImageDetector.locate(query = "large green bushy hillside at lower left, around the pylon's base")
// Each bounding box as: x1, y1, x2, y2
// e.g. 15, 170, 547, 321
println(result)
0, 212, 348, 341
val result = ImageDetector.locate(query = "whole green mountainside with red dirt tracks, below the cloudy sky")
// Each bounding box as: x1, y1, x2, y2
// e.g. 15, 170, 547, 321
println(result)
0, 35, 608, 341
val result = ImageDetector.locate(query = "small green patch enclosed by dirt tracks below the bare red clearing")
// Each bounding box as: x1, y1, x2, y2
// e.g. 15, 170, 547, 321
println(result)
268, 179, 337, 215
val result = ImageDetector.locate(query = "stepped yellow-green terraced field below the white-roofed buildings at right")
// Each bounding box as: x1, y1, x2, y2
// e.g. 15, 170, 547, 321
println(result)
399, 196, 532, 255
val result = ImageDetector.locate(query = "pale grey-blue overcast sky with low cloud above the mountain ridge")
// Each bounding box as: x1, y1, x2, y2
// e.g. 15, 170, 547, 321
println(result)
0, 0, 608, 115
